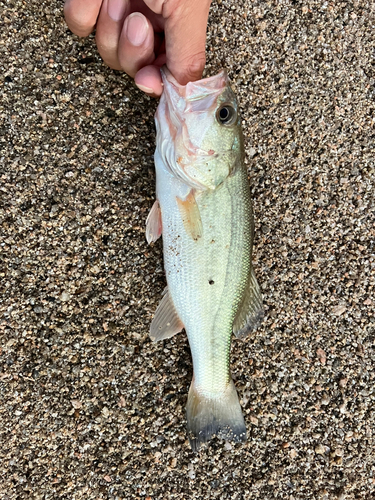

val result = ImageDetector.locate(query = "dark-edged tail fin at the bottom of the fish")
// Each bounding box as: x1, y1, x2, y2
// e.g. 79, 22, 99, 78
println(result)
186, 379, 246, 451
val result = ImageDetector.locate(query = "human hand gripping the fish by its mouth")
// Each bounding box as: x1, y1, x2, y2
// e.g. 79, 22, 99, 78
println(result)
64, 0, 211, 96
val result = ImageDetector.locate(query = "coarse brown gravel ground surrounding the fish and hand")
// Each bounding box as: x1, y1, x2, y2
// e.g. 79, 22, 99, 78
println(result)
0, 0, 375, 500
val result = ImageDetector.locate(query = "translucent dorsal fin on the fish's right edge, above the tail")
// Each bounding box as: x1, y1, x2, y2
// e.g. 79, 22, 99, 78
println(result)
233, 267, 264, 338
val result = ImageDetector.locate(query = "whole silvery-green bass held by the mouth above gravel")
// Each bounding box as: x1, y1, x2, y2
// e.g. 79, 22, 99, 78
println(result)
146, 67, 264, 452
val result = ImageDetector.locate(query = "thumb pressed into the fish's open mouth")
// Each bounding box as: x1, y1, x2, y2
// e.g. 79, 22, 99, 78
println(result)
163, 0, 211, 85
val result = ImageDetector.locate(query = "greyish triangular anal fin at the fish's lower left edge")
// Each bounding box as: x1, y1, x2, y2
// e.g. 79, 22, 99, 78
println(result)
150, 290, 184, 342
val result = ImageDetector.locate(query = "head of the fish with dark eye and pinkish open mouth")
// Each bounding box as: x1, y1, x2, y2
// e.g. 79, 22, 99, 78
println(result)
155, 68, 243, 190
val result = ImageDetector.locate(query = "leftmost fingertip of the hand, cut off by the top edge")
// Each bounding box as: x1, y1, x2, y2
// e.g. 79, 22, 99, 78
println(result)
64, 0, 102, 36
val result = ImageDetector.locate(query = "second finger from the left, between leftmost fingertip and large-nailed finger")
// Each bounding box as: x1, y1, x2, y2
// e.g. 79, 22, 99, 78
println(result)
95, 0, 130, 70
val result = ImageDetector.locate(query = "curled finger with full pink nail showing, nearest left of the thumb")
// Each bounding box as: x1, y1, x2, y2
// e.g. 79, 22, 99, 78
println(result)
118, 12, 155, 77
